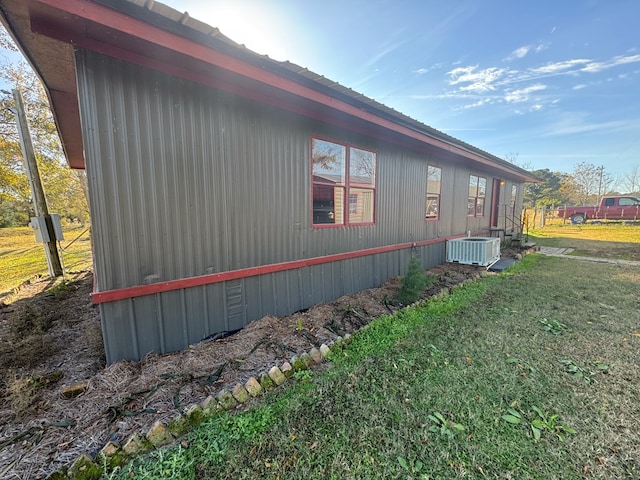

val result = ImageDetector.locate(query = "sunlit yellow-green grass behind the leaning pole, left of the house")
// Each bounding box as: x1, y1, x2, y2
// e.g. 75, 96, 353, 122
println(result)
0, 226, 92, 296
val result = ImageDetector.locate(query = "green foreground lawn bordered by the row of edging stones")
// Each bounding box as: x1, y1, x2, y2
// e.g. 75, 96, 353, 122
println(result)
111, 255, 640, 480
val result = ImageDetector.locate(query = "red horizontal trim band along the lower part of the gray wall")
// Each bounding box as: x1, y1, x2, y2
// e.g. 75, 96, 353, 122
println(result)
92, 232, 485, 303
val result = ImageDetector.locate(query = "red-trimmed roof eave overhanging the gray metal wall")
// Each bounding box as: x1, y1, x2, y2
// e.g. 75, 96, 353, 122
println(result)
0, 0, 539, 182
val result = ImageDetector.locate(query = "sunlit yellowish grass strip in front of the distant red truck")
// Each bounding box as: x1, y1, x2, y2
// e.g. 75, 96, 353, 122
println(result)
529, 223, 640, 261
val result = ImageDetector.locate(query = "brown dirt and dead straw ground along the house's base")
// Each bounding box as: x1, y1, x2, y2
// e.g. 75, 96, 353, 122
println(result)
0, 258, 500, 479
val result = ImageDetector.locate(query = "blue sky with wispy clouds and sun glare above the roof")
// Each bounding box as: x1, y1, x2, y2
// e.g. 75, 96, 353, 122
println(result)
170, 0, 640, 188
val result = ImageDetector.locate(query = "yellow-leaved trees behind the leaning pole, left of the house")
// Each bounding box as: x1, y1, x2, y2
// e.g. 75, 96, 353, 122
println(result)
0, 27, 89, 227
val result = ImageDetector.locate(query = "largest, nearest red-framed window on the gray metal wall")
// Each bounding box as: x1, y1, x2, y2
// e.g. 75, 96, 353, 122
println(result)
311, 138, 377, 226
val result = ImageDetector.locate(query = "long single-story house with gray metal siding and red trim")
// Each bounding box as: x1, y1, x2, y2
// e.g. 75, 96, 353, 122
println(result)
0, 0, 536, 363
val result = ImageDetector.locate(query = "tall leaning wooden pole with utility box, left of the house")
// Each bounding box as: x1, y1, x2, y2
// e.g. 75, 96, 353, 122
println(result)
12, 89, 62, 277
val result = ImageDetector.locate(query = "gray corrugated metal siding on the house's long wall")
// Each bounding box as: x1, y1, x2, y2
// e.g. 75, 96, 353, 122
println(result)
77, 51, 524, 362
